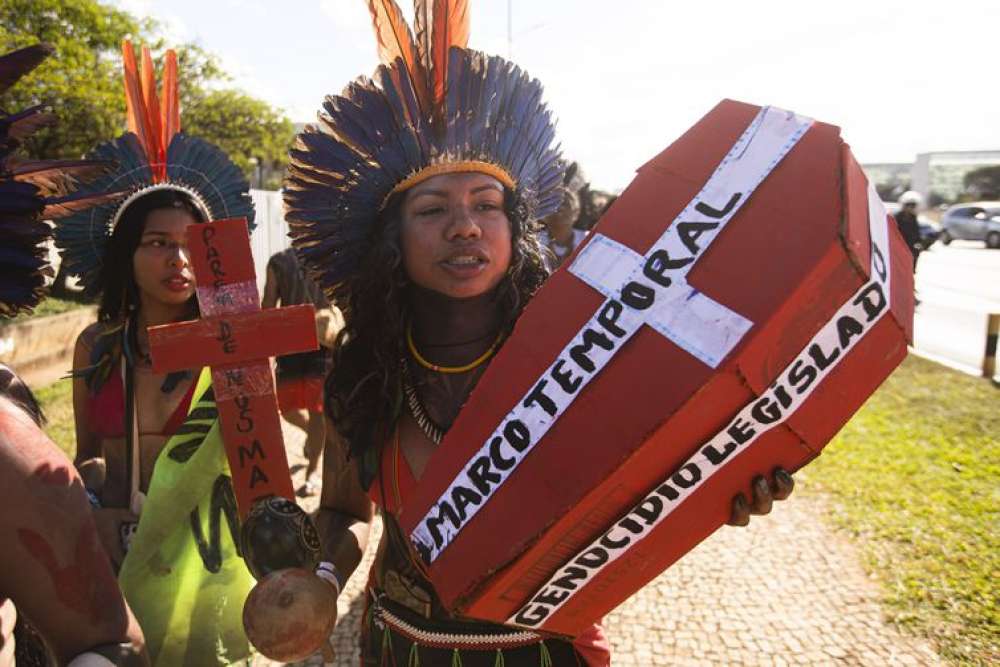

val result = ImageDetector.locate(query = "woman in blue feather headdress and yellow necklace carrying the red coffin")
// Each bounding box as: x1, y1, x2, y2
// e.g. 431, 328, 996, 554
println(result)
285, 0, 792, 667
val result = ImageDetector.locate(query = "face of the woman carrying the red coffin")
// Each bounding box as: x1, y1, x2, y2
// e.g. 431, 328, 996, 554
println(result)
400, 173, 511, 299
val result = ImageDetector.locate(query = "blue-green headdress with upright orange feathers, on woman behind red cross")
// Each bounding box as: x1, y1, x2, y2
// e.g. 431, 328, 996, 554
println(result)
55, 40, 254, 295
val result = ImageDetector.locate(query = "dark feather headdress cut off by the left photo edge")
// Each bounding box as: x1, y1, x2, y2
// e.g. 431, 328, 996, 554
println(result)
0, 44, 122, 317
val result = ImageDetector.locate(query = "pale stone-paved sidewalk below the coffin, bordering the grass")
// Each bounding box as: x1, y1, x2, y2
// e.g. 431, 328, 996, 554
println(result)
272, 428, 942, 667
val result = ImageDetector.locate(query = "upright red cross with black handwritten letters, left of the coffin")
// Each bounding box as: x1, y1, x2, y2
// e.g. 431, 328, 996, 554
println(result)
149, 218, 318, 519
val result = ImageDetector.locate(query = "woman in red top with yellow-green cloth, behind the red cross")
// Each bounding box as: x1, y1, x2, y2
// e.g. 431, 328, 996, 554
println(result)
55, 42, 253, 666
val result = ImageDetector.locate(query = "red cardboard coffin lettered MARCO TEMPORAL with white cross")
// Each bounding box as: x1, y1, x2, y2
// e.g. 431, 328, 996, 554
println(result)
401, 101, 913, 635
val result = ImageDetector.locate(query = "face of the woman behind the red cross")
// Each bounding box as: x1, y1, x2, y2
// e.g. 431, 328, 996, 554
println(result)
132, 208, 197, 306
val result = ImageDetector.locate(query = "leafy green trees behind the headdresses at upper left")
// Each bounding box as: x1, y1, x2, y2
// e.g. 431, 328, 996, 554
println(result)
0, 0, 294, 187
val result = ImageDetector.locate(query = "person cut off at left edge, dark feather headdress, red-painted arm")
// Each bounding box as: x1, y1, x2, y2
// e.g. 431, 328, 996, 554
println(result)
0, 44, 148, 667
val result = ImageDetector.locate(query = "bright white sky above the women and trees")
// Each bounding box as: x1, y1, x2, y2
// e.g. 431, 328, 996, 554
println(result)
113, 0, 1000, 189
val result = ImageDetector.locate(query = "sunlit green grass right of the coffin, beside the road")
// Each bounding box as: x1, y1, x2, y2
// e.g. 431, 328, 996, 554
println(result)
800, 357, 1000, 664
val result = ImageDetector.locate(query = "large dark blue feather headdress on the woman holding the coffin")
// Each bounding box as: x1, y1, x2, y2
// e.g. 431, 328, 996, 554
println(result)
284, 0, 563, 291
